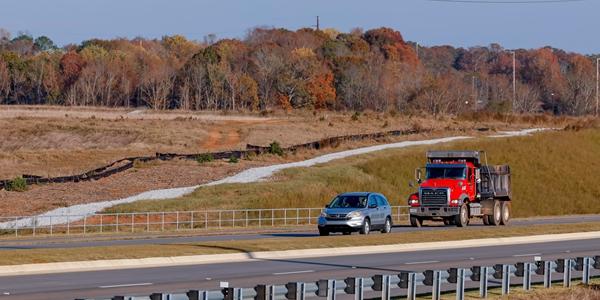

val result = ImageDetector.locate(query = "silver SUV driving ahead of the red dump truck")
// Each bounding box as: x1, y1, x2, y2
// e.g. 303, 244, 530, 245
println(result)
319, 192, 392, 236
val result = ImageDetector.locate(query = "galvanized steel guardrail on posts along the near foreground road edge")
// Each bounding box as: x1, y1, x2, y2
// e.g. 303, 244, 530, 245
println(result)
76, 256, 600, 300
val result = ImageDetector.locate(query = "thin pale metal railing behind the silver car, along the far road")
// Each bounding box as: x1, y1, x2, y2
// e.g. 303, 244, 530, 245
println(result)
0, 206, 408, 237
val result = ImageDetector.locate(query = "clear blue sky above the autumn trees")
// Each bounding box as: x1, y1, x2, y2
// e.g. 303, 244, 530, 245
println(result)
0, 0, 600, 53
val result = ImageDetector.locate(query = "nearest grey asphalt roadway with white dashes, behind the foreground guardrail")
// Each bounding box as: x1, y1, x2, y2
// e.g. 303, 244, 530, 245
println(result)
0, 239, 600, 300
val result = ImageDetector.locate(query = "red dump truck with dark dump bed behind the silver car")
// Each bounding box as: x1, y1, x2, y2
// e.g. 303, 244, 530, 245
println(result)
408, 151, 511, 227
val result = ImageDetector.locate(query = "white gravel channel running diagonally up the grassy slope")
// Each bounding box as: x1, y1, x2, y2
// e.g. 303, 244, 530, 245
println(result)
0, 128, 547, 229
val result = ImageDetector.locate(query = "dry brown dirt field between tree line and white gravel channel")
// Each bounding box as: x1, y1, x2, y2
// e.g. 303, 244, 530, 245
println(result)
0, 106, 580, 216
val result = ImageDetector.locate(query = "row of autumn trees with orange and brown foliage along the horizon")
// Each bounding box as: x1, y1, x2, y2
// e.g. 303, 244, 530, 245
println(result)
0, 28, 597, 115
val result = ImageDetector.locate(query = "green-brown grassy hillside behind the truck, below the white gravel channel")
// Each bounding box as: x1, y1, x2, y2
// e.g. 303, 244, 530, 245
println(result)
110, 129, 600, 217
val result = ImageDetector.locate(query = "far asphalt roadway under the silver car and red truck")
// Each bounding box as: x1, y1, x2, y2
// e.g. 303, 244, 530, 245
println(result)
0, 215, 600, 250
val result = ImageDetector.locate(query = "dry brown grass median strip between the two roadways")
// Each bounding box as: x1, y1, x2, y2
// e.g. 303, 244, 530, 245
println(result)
0, 222, 600, 265
